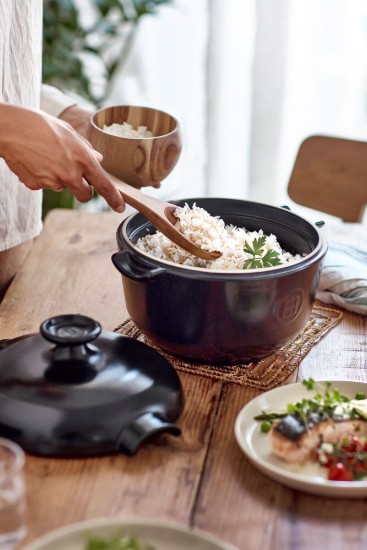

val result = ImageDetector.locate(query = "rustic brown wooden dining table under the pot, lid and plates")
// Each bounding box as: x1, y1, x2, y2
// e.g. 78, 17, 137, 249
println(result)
0, 210, 367, 550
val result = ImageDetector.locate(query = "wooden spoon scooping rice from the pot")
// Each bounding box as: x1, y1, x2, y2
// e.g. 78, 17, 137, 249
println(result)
108, 174, 221, 260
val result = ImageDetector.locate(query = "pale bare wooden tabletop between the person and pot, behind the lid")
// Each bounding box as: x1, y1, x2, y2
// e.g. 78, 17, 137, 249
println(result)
0, 210, 127, 338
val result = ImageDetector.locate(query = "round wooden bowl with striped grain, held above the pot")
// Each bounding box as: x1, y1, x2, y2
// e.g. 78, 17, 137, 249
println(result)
89, 105, 182, 188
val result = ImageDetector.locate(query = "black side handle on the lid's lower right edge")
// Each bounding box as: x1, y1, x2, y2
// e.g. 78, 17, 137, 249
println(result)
117, 412, 181, 456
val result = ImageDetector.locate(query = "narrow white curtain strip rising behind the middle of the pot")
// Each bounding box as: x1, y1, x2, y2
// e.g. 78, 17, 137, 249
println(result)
204, 0, 256, 198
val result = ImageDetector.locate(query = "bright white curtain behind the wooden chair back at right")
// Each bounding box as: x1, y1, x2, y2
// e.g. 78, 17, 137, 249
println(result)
275, 0, 367, 219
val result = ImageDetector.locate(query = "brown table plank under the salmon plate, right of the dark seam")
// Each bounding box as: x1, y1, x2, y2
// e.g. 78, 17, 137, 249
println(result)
194, 384, 367, 550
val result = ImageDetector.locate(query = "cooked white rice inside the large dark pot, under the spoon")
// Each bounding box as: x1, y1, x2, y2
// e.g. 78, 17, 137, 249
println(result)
136, 204, 302, 271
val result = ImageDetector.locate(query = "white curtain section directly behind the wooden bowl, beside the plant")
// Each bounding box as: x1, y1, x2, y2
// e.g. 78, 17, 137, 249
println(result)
105, 0, 209, 199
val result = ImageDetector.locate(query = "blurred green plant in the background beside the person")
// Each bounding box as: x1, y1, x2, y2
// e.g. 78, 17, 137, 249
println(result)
42, 0, 174, 217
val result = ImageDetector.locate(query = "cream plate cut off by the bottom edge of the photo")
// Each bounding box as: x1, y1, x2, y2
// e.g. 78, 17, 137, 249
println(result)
23, 518, 237, 550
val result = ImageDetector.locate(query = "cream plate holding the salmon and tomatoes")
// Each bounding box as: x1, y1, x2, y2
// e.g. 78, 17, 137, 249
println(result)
234, 380, 367, 498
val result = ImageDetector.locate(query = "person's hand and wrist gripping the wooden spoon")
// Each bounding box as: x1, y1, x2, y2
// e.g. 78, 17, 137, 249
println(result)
0, 104, 125, 212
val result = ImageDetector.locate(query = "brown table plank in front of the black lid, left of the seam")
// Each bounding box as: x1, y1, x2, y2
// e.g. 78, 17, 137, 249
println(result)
21, 374, 224, 547
